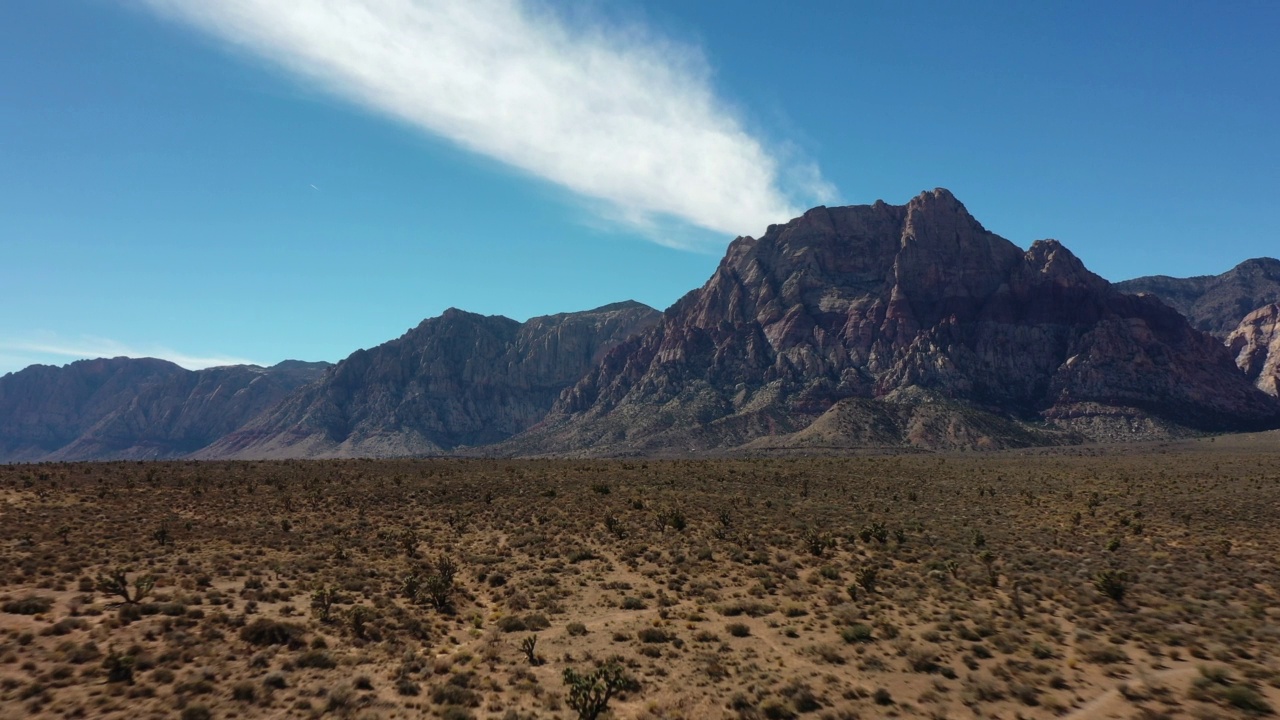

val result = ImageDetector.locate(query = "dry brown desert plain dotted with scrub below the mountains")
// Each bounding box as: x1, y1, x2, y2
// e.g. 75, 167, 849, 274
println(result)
0, 441, 1280, 720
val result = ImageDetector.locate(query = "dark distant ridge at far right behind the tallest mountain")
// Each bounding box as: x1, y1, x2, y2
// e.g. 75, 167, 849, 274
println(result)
1115, 258, 1280, 338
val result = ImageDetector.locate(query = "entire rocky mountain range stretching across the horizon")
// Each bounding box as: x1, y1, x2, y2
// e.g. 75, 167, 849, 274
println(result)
0, 190, 1280, 462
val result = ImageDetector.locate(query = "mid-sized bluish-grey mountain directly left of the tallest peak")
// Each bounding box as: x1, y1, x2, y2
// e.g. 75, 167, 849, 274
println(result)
197, 302, 658, 457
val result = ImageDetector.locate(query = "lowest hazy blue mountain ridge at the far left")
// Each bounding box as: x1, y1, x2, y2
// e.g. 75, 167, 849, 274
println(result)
0, 357, 329, 462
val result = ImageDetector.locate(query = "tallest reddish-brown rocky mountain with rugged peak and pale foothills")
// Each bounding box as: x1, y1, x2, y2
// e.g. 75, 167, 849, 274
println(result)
495, 190, 1280, 454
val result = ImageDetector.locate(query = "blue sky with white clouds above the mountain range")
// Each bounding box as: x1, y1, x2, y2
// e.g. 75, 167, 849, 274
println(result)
0, 0, 1280, 373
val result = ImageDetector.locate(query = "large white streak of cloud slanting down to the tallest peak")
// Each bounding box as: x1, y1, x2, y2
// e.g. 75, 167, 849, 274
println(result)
133, 0, 833, 240
